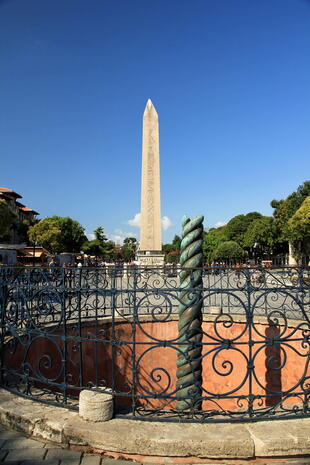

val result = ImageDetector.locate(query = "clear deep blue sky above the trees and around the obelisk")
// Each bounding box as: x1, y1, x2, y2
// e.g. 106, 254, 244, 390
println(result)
0, 0, 310, 242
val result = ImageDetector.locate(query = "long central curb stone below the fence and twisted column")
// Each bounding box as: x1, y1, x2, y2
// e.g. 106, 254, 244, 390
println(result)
64, 418, 254, 458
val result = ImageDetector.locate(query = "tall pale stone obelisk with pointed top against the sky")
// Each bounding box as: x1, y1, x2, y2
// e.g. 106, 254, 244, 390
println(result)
138, 99, 164, 266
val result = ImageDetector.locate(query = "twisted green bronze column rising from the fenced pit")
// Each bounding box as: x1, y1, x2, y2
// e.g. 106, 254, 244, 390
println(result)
176, 216, 203, 411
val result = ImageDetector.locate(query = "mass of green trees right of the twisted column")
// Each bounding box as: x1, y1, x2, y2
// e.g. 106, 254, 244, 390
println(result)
163, 181, 310, 263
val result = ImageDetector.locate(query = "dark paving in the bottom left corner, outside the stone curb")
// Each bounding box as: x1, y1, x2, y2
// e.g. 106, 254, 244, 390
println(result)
0, 426, 131, 465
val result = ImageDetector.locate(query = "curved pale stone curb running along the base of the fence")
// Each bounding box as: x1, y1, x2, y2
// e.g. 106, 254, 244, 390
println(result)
0, 390, 310, 463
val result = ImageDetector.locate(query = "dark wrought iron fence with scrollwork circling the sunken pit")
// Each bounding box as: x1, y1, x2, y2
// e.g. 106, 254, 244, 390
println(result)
0, 266, 310, 421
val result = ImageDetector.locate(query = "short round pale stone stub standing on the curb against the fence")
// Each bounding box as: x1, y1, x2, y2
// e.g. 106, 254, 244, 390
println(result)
79, 389, 113, 422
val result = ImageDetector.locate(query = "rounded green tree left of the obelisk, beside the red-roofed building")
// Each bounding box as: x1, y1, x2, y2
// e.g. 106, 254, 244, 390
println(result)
28, 216, 86, 253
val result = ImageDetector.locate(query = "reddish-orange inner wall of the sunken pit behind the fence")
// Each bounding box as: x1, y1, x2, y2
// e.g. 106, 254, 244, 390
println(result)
4, 316, 310, 410
